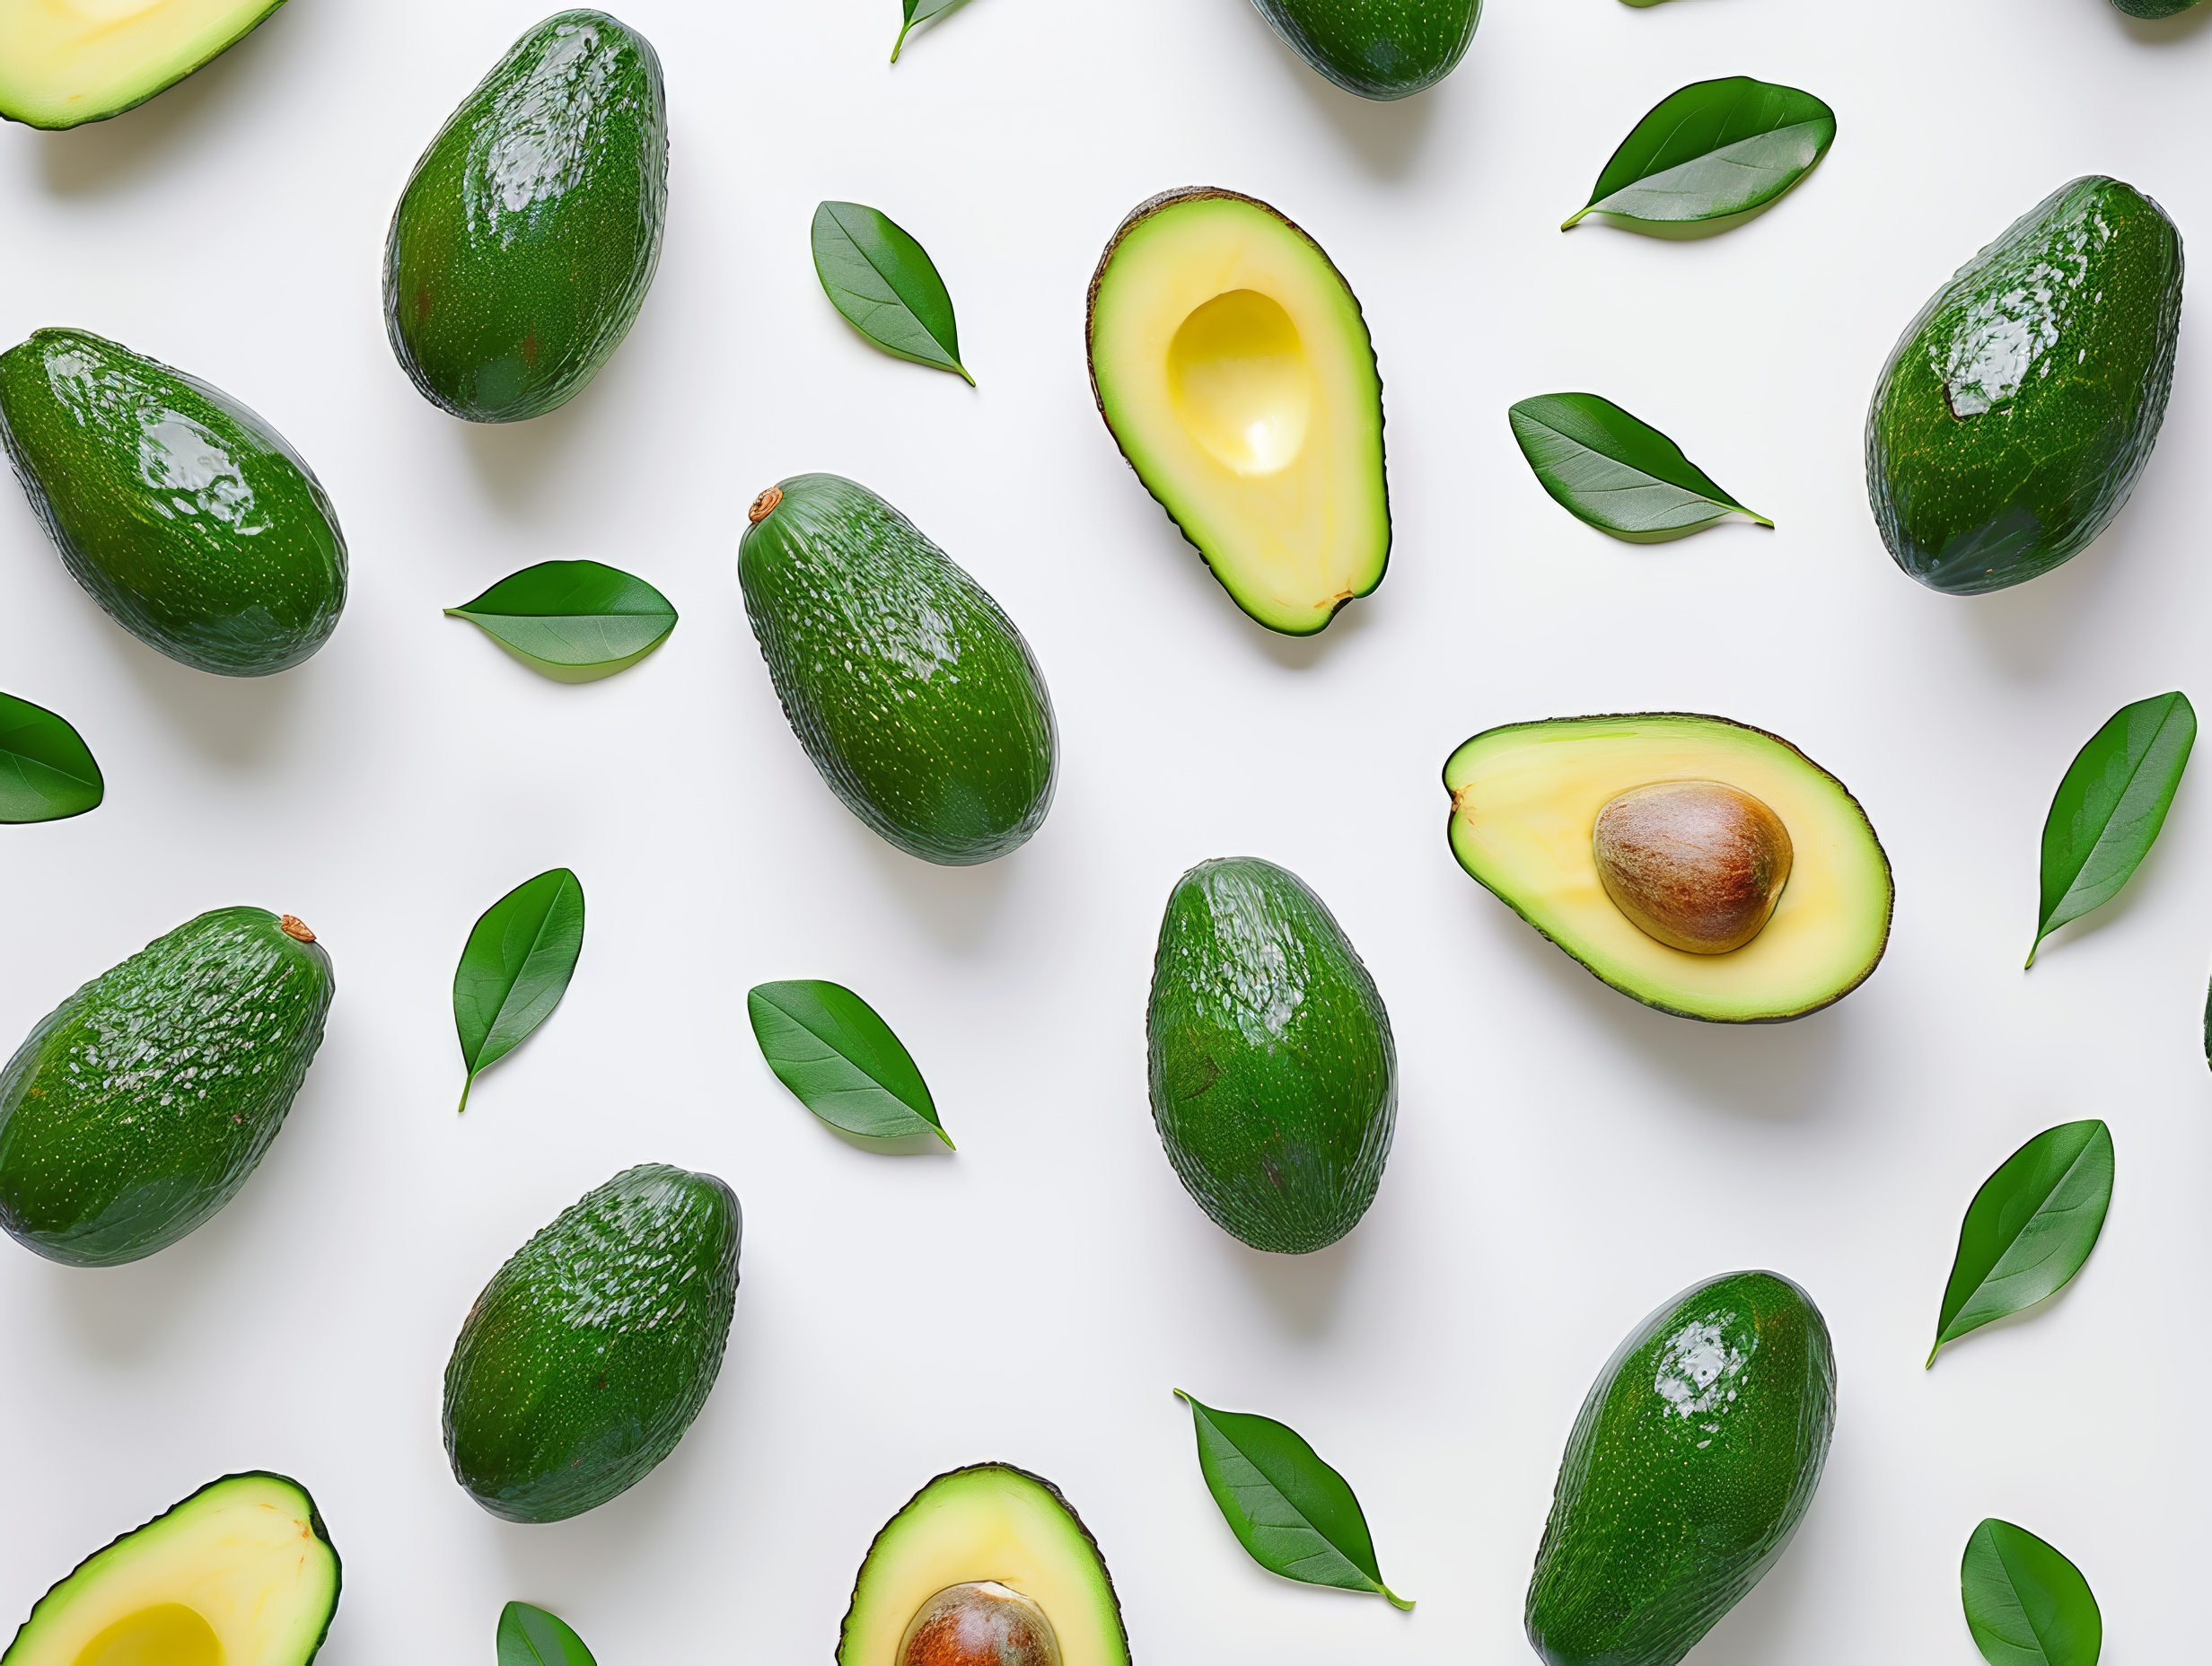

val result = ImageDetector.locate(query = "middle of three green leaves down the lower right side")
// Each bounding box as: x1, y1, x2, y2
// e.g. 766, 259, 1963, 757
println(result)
1929, 1122, 2112, 1365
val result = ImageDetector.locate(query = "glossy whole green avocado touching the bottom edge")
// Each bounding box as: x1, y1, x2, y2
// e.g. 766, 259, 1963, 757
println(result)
1524, 1272, 1836, 1666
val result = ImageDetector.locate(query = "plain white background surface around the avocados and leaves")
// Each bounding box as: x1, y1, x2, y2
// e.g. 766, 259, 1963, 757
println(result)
0, 0, 2212, 1666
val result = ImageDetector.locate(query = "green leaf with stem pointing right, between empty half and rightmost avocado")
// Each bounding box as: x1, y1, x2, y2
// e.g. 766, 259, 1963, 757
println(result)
1506, 394, 1774, 544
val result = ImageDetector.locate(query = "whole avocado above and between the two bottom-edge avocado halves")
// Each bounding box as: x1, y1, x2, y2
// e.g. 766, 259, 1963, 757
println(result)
444, 1163, 745, 1522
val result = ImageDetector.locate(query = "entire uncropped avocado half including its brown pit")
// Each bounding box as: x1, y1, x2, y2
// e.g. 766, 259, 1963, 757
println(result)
1444, 713, 1893, 1024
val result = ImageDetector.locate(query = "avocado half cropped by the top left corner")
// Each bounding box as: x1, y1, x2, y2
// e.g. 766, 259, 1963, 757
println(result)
0, 0, 283, 128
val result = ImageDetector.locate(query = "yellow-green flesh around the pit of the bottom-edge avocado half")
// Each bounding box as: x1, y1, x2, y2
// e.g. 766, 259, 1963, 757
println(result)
836, 1462, 1128, 1666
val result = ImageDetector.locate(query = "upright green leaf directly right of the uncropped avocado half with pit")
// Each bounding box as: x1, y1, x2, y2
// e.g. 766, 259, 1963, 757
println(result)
2028, 695, 2197, 967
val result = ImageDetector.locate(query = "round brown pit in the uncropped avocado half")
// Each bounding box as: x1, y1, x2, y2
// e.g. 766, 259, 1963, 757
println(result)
1591, 781, 1789, 953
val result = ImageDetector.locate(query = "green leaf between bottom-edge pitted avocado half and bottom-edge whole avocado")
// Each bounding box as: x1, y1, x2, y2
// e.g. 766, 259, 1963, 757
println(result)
1174, 1390, 1413, 1609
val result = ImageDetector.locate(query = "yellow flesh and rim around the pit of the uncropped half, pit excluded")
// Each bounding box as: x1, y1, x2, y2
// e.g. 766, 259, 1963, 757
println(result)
1444, 713, 1893, 1024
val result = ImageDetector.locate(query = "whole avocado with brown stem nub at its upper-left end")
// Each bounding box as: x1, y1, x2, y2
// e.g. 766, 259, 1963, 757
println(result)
737, 473, 1059, 867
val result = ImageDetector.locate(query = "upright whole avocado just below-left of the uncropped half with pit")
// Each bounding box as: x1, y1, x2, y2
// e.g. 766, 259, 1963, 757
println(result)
1144, 856, 1398, 1255
